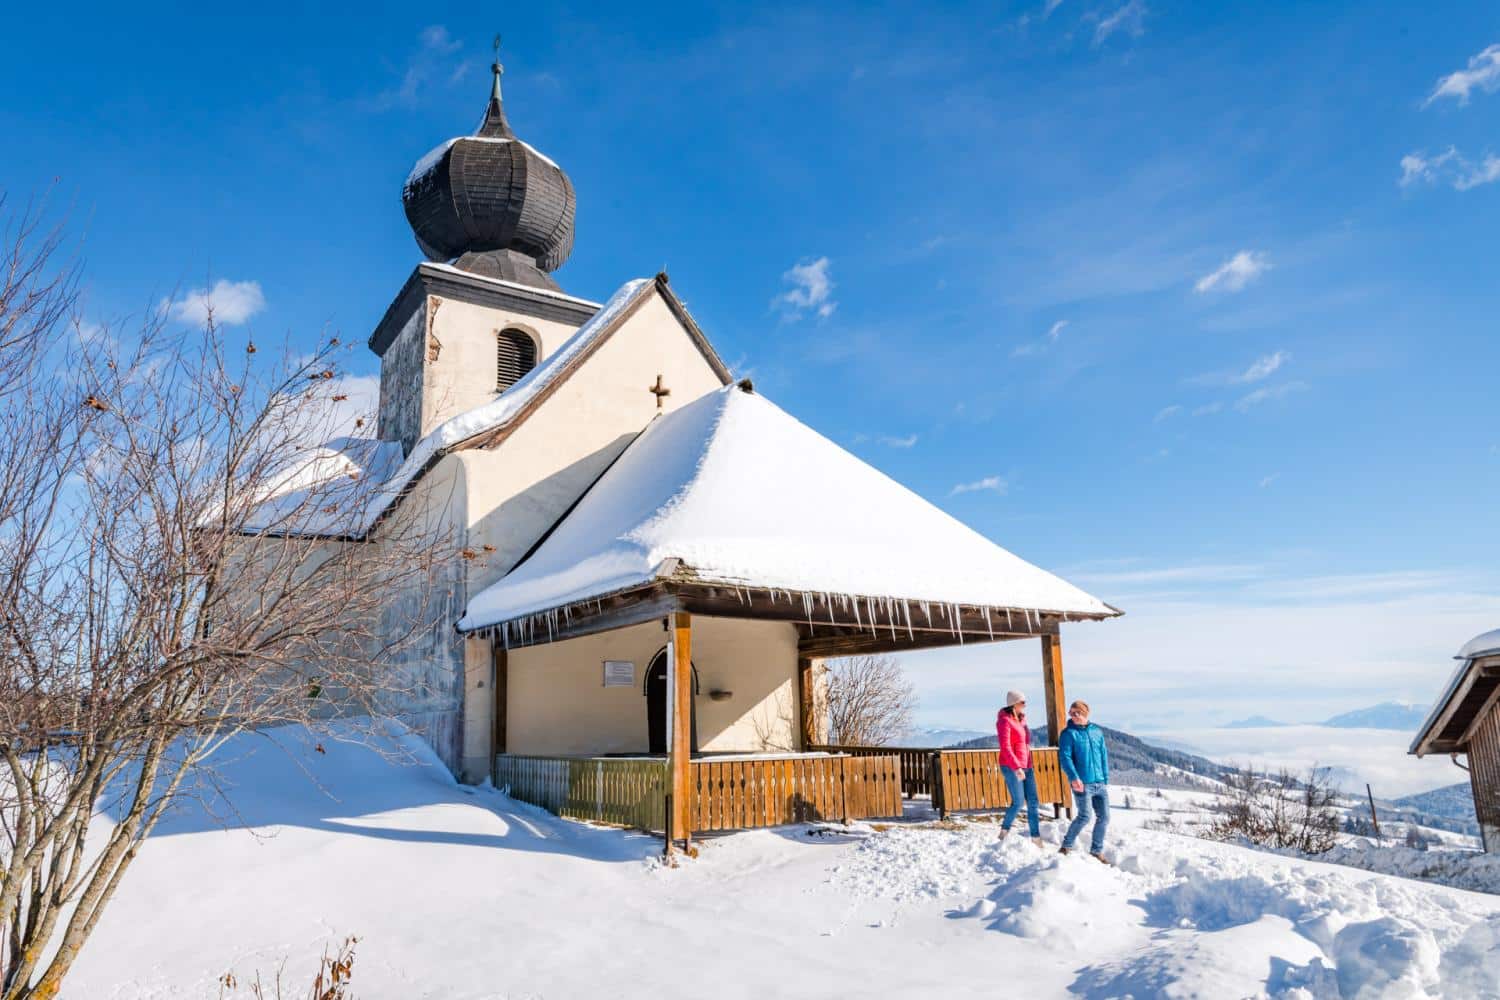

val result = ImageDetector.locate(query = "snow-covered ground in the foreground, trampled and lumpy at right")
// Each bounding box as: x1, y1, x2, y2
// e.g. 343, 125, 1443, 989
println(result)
65, 733, 1500, 1000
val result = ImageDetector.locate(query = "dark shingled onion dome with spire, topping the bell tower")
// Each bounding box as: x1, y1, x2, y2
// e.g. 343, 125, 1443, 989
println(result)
401, 52, 576, 291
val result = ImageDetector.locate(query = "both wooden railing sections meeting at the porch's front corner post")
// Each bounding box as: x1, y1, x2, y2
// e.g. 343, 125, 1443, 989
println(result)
495, 754, 902, 832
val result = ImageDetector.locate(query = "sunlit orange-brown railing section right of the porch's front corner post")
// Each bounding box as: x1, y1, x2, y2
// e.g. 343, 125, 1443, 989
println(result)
692, 754, 902, 832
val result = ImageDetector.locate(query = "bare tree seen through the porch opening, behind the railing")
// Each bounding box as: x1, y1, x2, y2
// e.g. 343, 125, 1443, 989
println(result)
815, 655, 917, 747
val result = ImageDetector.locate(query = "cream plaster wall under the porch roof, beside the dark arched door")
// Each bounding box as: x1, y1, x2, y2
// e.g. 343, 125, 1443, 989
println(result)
506, 618, 797, 756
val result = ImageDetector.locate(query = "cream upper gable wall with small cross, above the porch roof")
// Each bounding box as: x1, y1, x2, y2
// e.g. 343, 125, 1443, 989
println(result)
458, 284, 722, 594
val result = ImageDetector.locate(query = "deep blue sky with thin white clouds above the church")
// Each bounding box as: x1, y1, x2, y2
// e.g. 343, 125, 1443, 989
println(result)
0, 0, 1500, 743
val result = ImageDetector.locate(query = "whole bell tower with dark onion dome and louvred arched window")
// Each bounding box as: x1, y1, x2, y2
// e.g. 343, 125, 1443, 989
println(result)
369, 43, 599, 453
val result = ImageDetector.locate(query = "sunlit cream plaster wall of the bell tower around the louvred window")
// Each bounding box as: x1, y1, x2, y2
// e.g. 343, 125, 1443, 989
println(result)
422, 295, 578, 433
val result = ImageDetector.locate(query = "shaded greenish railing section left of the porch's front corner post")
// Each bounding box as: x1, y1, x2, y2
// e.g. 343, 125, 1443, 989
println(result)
495, 754, 666, 831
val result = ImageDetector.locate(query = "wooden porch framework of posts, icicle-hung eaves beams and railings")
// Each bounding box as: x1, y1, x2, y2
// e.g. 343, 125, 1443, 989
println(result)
476, 578, 1098, 853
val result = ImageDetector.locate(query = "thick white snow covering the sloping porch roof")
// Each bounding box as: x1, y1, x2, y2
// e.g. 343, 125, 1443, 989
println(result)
458, 385, 1119, 631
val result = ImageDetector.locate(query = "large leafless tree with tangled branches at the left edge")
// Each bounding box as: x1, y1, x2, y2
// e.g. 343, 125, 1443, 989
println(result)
0, 199, 441, 1000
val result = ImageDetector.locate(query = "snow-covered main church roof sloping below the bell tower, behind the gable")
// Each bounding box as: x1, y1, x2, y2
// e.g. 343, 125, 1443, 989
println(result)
248, 277, 651, 537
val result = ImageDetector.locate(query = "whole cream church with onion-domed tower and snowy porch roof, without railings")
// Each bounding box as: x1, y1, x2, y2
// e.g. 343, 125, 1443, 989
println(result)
261, 50, 1119, 834
